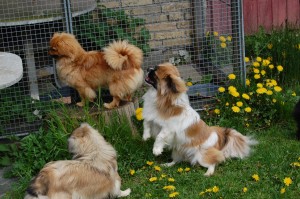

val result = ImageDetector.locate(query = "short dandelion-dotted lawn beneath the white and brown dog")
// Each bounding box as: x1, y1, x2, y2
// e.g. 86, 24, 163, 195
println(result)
116, 118, 300, 199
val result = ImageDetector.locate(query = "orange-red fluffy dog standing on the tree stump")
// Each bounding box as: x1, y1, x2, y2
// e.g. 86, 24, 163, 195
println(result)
49, 33, 144, 109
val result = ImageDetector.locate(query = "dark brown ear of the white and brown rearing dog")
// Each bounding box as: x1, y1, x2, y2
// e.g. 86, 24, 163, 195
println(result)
161, 74, 187, 95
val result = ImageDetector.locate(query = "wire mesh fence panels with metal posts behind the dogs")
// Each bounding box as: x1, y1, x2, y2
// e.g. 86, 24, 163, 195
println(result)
0, 0, 245, 137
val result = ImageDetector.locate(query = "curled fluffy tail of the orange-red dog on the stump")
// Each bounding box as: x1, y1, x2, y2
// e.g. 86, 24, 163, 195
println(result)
103, 40, 143, 70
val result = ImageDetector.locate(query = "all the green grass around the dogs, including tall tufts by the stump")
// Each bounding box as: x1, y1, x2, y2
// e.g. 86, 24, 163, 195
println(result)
4, 103, 300, 199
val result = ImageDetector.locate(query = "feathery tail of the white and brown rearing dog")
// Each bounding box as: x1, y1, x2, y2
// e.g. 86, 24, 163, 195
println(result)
222, 129, 258, 159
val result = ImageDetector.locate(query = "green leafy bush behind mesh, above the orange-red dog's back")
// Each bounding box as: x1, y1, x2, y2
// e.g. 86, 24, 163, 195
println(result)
74, 6, 151, 55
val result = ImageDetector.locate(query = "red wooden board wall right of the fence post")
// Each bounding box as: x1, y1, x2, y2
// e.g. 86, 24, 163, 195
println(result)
243, 0, 300, 34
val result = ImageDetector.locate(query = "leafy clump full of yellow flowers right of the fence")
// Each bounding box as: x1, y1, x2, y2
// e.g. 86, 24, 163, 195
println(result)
214, 57, 296, 128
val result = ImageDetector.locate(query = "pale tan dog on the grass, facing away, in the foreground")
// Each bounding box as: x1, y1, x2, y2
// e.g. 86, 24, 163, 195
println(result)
25, 123, 131, 199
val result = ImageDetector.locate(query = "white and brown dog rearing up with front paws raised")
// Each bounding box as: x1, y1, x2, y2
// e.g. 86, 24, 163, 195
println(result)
143, 63, 257, 176
